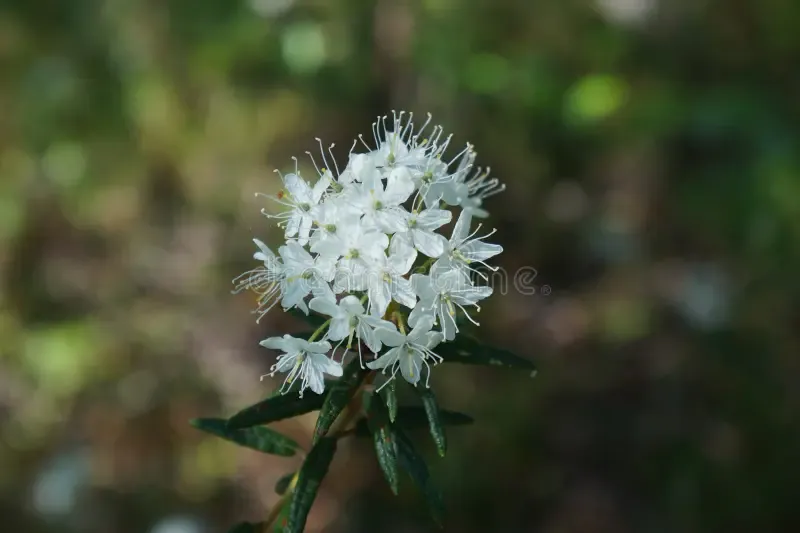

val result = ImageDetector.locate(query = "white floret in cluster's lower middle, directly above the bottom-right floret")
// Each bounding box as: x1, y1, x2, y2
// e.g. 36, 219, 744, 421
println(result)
366, 234, 417, 317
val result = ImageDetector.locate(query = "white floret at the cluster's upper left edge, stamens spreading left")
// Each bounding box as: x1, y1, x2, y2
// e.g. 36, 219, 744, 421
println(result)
262, 170, 330, 245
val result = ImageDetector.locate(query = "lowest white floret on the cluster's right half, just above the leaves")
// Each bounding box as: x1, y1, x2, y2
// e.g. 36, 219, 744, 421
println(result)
367, 318, 442, 386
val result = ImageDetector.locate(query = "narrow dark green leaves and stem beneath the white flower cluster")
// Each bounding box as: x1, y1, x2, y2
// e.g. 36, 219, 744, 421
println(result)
192, 308, 530, 533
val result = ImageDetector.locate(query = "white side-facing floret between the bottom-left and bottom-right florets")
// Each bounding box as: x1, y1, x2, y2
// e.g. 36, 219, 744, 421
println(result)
308, 292, 392, 368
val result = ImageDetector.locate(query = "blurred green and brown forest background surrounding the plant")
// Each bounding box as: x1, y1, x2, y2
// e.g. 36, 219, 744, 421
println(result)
0, 0, 800, 533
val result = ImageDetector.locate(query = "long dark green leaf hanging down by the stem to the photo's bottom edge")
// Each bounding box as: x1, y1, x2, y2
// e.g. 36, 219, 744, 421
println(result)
286, 437, 338, 533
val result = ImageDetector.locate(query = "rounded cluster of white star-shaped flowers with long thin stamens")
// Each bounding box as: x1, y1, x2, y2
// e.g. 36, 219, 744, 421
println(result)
234, 112, 504, 395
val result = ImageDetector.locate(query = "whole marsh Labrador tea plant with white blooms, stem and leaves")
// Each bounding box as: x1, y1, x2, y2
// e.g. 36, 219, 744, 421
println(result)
192, 112, 532, 533
